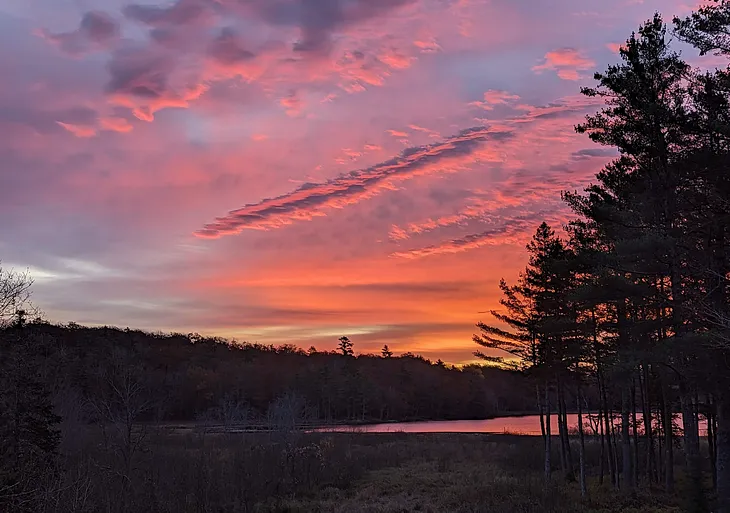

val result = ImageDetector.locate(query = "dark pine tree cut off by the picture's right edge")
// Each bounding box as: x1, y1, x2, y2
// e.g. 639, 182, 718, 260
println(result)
674, 9, 730, 513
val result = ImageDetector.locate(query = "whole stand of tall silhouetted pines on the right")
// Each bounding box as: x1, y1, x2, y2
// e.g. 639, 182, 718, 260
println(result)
474, 10, 730, 512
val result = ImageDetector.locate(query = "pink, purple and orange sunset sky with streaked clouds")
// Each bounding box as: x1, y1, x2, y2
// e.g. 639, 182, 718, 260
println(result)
0, 0, 716, 363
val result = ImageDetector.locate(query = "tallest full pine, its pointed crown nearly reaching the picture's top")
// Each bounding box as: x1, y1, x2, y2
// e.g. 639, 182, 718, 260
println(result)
567, 15, 699, 488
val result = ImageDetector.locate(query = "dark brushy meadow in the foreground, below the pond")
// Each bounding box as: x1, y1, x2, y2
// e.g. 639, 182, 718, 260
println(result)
41, 431, 686, 513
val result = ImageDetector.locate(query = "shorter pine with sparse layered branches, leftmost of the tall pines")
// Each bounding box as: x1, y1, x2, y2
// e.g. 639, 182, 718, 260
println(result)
473, 223, 580, 479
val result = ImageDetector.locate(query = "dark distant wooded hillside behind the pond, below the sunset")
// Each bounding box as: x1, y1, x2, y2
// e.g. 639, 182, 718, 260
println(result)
0, 323, 534, 425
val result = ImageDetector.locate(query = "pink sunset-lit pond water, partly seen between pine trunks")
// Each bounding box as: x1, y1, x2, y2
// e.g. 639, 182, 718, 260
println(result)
322, 414, 706, 435
